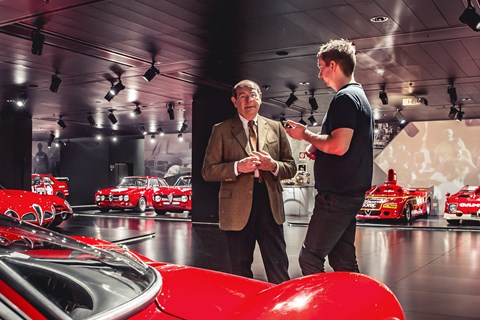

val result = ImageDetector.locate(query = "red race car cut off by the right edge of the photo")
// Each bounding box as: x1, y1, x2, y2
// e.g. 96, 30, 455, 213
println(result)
443, 185, 480, 225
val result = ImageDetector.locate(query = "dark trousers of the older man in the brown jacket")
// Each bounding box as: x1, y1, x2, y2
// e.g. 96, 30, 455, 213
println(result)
226, 182, 290, 283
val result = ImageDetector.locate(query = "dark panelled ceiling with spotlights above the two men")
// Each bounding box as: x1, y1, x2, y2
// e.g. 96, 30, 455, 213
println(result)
0, 0, 480, 140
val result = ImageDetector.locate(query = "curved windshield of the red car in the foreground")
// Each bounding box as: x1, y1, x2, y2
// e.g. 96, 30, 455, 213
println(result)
0, 215, 160, 319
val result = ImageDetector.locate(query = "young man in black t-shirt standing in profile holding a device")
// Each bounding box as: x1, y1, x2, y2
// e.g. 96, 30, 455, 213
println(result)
286, 39, 373, 275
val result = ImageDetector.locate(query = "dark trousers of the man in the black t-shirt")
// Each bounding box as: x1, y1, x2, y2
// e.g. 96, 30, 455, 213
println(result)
299, 193, 364, 275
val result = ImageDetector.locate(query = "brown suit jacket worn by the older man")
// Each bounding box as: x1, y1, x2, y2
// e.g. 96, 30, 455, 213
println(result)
202, 115, 296, 230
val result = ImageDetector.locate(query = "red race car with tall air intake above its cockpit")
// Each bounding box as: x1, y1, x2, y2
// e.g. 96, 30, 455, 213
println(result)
357, 169, 433, 222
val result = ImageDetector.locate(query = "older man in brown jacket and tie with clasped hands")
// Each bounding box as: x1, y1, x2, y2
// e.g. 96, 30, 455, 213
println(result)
202, 80, 296, 283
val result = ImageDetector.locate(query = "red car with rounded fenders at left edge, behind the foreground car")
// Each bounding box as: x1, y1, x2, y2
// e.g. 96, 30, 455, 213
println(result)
0, 186, 73, 227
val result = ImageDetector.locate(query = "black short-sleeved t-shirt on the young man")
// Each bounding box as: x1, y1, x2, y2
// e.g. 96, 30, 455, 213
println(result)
314, 83, 373, 196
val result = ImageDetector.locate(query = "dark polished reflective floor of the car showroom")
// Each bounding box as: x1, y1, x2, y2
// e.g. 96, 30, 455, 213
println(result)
57, 209, 480, 320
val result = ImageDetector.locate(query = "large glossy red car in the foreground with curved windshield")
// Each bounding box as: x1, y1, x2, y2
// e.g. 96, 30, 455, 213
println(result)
0, 216, 405, 320
